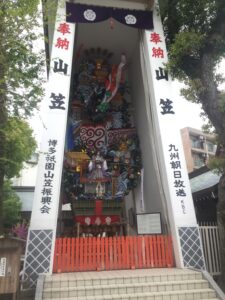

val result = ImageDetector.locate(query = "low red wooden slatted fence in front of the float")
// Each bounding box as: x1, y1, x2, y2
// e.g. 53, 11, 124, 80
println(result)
53, 235, 174, 273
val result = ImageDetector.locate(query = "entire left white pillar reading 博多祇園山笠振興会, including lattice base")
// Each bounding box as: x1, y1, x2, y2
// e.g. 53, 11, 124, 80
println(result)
24, 1, 75, 286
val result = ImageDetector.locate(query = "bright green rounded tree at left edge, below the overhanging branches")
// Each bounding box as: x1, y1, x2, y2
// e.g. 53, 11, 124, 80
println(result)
0, 117, 36, 234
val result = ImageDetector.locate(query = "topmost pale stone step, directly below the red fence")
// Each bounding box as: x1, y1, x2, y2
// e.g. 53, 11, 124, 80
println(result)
44, 269, 202, 289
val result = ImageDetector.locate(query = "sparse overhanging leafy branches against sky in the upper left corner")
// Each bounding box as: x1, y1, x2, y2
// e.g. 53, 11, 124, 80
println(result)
0, 0, 45, 116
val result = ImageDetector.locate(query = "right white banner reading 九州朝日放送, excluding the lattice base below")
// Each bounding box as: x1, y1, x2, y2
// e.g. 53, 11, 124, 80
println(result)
144, 12, 196, 225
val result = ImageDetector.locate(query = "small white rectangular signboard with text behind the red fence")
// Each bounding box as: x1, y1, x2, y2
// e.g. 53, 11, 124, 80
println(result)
137, 213, 162, 234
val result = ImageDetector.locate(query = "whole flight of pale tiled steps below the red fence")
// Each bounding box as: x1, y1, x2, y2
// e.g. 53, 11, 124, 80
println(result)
40, 268, 221, 300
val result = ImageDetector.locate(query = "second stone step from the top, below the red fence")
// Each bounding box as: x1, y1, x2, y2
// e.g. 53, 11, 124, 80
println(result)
43, 280, 209, 298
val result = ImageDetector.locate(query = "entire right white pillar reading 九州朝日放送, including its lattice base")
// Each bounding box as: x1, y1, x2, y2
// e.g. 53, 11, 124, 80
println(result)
143, 2, 205, 267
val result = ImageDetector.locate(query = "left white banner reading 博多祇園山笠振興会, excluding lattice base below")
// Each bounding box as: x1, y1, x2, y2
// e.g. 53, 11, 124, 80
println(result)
30, 4, 75, 229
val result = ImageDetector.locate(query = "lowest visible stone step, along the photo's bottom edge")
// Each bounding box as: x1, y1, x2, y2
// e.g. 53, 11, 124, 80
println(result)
43, 289, 217, 300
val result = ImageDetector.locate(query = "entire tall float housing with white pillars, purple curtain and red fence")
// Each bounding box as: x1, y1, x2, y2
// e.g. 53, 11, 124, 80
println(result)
24, 0, 204, 287
